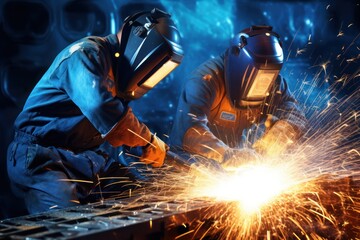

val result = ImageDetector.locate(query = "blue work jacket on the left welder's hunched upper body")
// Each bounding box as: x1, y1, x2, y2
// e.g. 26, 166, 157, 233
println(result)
15, 34, 127, 151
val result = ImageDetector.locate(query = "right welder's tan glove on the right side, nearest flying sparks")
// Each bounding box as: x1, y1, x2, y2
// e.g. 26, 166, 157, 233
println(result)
253, 120, 299, 157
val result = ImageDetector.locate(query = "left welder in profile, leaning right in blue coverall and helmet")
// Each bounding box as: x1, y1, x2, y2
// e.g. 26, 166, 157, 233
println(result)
7, 9, 183, 213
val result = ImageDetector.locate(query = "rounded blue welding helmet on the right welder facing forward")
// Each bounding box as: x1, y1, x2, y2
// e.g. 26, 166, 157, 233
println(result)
225, 26, 284, 108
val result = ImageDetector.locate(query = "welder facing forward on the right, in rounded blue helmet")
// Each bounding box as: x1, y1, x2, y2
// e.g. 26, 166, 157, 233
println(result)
170, 25, 306, 168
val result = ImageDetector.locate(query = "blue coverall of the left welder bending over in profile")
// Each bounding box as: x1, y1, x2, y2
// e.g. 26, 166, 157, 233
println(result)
7, 34, 151, 213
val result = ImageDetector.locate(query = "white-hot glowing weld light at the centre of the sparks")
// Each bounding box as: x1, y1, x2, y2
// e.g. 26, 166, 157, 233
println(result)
188, 164, 296, 214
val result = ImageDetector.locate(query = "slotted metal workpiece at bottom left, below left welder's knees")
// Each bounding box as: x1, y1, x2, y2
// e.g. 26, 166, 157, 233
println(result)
0, 198, 221, 239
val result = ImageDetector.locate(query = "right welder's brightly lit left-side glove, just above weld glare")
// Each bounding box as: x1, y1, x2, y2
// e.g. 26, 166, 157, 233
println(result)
221, 148, 260, 170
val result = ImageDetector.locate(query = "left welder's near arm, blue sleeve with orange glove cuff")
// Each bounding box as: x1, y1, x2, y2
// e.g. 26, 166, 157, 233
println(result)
62, 47, 151, 146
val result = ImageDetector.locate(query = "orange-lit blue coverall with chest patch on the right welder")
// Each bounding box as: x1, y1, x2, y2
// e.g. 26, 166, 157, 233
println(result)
170, 52, 306, 162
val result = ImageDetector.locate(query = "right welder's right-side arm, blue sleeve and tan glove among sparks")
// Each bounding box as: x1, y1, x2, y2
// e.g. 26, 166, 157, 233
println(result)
253, 76, 307, 157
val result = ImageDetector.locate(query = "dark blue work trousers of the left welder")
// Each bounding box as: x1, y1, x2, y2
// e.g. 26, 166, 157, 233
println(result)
7, 132, 139, 214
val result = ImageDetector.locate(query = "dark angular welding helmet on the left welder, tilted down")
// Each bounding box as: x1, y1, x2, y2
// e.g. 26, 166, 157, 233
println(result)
115, 8, 183, 100
